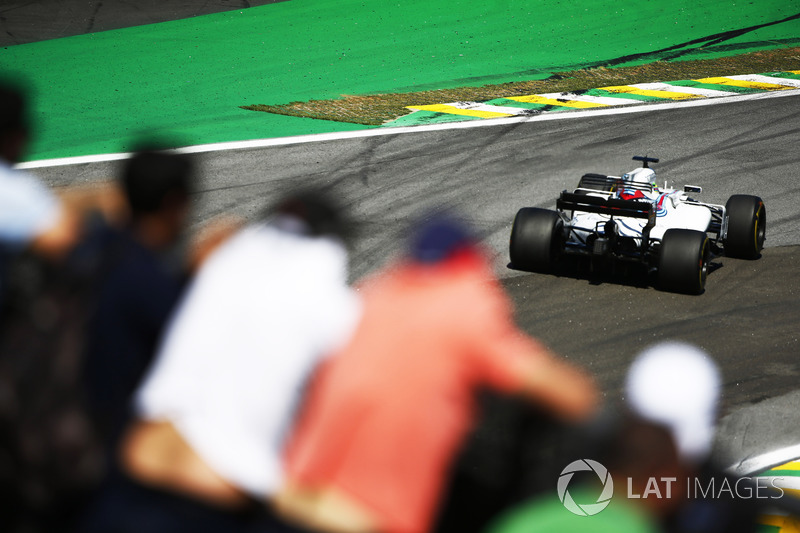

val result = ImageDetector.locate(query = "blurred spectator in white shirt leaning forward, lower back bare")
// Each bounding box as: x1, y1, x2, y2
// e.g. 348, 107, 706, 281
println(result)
78, 192, 360, 533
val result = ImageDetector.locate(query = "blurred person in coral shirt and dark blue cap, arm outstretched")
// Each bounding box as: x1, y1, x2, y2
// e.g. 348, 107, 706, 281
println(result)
277, 215, 597, 533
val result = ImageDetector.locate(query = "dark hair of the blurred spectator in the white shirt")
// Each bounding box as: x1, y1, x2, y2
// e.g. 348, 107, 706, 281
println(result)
272, 189, 354, 241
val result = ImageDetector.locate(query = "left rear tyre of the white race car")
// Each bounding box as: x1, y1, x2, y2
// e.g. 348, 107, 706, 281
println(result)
509, 207, 564, 272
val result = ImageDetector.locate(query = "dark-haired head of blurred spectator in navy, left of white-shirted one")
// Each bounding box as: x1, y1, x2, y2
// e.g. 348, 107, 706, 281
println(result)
122, 150, 194, 217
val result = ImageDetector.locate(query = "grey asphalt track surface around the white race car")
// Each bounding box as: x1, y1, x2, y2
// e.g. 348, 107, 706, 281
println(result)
10, 2, 800, 470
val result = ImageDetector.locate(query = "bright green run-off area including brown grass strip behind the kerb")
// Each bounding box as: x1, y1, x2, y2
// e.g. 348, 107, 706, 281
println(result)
0, 0, 800, 159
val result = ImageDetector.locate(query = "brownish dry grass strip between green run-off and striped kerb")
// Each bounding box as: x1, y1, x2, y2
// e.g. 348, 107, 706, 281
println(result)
242, 48, 800, 126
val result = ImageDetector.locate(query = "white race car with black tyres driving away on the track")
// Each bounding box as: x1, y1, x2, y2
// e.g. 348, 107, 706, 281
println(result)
510, 156, 767, 294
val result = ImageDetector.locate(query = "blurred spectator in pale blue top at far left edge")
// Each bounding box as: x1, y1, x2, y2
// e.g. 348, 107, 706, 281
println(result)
0, 77, 122, 533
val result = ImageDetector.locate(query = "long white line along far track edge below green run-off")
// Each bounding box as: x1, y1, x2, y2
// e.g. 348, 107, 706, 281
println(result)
17, 89, 800, 169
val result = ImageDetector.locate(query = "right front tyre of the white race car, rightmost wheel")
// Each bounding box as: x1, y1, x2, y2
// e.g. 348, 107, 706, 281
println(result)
722, 194, 767, 259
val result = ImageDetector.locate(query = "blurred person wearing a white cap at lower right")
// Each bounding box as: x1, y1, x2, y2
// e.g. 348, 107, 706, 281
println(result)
625, 342, 774, 533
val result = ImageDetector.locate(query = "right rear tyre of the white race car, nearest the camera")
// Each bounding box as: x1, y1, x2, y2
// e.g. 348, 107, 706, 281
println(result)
658, 229, 710, 294
